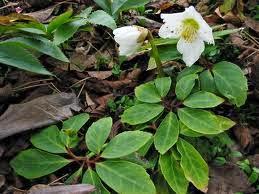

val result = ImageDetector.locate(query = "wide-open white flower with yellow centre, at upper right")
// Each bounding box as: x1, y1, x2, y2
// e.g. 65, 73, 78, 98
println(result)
159, 6, 214, 66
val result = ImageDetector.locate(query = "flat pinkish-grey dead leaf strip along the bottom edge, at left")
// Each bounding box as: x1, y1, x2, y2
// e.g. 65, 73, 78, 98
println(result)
28, 184, 95, 194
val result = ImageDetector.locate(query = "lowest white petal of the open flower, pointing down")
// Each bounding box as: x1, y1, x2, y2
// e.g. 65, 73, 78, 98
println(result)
177, 38, 205, 67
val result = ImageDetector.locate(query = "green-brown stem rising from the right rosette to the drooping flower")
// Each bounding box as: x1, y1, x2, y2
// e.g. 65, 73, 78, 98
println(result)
147, 31, 164, 77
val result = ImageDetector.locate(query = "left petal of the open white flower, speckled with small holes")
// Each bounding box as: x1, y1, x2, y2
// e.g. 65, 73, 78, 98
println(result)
159, 13, 183, 38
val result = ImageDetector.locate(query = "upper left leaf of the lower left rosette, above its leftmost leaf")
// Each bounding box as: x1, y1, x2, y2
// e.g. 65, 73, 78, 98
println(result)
30, 125, 67, 153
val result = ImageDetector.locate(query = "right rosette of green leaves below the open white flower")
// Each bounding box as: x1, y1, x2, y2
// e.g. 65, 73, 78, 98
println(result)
121, 61, 248, 194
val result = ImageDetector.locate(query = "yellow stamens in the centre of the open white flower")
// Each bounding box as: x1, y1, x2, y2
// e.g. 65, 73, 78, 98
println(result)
181, 18, 200, 42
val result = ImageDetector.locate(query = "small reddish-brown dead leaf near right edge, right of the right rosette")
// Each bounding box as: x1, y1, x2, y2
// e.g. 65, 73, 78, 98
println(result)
233, 126, 253, 149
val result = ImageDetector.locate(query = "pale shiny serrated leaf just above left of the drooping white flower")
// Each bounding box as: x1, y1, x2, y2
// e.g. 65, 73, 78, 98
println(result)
88, 10, 117, 30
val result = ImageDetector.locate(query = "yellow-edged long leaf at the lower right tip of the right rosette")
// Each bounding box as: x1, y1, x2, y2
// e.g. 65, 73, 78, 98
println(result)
176, 139, 209, 192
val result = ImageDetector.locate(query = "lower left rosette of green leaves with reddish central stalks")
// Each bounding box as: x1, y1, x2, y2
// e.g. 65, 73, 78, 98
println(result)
10, 113, 156, 194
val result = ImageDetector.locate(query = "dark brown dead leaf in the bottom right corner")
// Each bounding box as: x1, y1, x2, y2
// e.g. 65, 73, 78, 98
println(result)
207, 164, 254, 194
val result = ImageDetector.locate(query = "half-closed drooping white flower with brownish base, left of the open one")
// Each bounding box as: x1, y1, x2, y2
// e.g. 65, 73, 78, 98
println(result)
113, 26, 148, 56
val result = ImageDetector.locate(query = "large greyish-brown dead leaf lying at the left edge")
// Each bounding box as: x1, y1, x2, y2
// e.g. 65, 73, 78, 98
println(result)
0, 93, 81, 139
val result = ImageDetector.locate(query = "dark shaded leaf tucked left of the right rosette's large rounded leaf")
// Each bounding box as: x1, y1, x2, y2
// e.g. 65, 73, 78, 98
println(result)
199, 70, 217, 93
